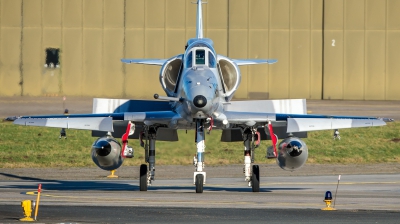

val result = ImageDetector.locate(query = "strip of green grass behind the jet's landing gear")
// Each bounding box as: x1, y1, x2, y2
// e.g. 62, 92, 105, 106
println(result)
0, 122, 400, 168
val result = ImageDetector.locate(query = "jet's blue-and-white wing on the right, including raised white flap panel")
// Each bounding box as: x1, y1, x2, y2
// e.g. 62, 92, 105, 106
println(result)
220, 99, 393, 133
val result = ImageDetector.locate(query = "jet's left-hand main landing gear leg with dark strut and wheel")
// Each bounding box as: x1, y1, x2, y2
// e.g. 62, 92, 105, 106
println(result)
139, 127, 157, 191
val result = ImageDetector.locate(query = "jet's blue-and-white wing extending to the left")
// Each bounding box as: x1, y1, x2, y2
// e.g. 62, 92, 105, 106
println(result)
14, 111, 180, 132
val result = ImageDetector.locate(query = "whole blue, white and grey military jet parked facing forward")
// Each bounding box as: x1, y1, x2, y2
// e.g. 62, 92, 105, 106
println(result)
14, 0, 390, 193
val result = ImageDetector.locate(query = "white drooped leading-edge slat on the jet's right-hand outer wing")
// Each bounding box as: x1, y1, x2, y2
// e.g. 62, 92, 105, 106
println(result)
287, 118, 386, 133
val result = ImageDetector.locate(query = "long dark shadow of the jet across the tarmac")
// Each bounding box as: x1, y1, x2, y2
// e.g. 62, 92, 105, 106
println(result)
0, 173, 309, 193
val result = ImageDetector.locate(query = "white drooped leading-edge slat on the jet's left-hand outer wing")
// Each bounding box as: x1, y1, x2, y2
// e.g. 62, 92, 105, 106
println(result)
14, 117, 113, 132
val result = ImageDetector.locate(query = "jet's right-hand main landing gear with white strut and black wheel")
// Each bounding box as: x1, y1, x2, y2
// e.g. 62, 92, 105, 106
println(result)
243, 128, 260, 192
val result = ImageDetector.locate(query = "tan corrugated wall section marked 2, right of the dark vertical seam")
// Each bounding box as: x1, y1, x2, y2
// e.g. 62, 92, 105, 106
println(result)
323, 0, 400, 100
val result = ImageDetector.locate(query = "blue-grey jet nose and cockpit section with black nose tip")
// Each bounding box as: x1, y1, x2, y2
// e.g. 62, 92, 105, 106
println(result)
173, 38, 230, 121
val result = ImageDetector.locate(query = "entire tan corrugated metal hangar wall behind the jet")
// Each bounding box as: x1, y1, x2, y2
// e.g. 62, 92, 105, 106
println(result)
0, 0, 400, 100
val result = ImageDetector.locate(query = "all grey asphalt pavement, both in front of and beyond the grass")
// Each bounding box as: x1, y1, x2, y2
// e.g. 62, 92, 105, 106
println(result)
0, 97, 400, 223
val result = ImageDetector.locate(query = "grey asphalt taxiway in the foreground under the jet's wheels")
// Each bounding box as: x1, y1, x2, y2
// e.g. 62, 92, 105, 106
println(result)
0, 174, 400, 223
